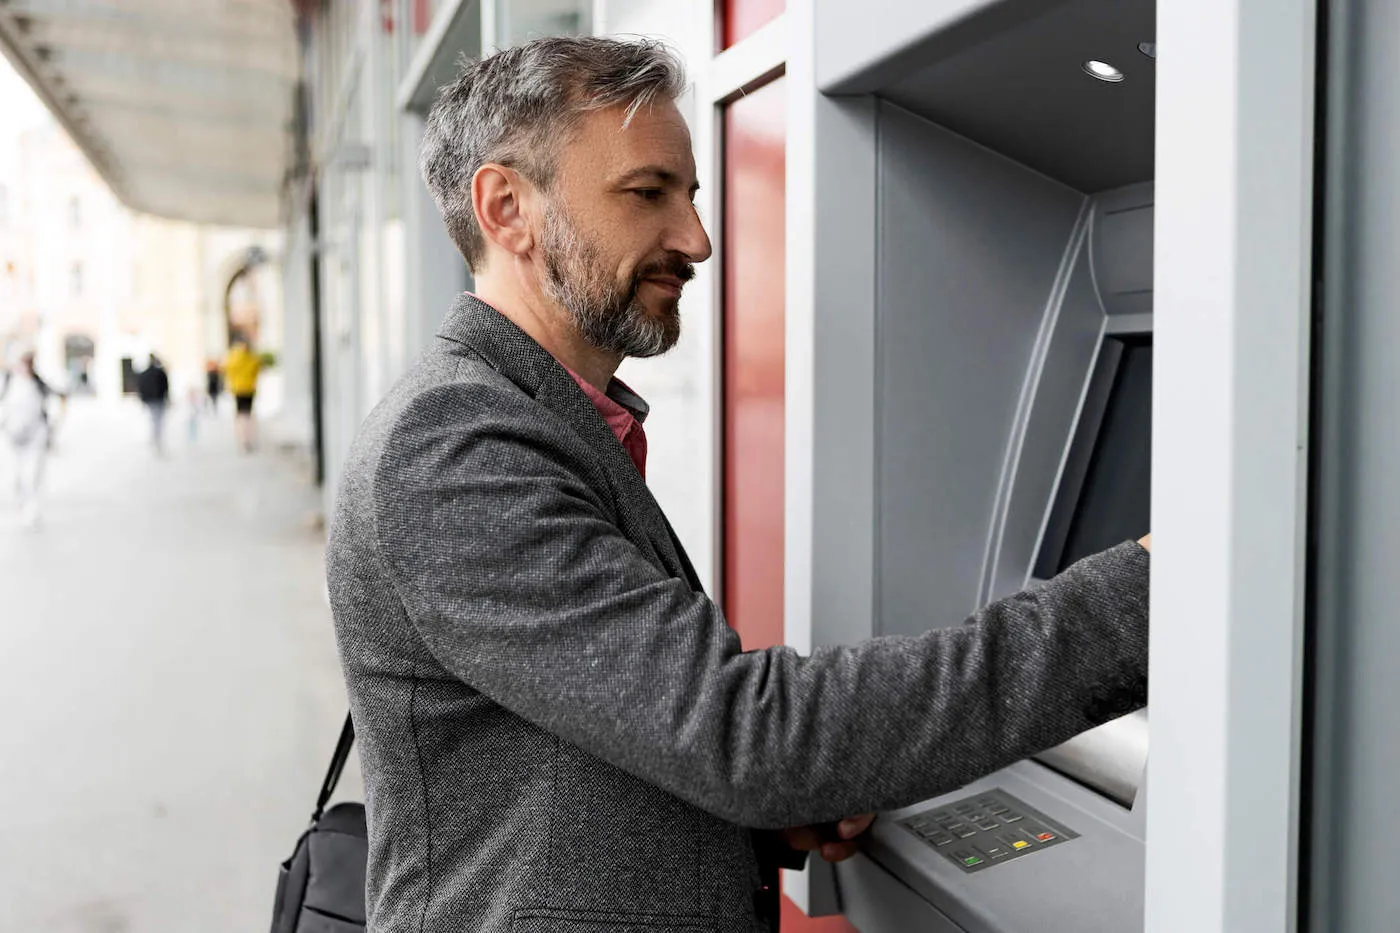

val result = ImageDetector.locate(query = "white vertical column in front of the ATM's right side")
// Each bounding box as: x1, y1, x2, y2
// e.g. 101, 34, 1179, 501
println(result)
1147, 0, 1316, 933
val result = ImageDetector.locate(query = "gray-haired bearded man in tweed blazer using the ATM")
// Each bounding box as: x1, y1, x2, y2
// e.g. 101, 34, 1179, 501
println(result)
328, 39, 1148, 933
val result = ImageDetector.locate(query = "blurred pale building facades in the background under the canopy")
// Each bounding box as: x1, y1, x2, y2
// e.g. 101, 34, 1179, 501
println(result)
0, 109, 284, 406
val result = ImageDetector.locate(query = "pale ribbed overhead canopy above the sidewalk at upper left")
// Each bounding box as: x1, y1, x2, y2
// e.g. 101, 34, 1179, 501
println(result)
0, 0, 297, 227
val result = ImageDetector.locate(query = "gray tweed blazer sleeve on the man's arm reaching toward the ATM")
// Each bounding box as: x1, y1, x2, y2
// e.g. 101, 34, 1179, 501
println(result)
374, 384, 1148, 828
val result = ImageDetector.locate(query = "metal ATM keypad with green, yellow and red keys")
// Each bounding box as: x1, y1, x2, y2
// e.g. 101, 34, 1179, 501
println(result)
900, 790, 1078, 874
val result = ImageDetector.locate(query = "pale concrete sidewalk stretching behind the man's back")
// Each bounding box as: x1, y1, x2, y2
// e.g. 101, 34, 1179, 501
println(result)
0, 399, 358, 933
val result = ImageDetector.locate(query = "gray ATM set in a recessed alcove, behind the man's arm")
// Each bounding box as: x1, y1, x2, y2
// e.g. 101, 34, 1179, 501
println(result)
811, 0, 1156, 933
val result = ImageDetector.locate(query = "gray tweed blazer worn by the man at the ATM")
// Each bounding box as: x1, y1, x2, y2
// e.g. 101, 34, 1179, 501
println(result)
326, 296, 1148, 933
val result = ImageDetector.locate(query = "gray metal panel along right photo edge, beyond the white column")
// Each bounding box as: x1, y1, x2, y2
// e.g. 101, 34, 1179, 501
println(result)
1302, 0, 1400, 933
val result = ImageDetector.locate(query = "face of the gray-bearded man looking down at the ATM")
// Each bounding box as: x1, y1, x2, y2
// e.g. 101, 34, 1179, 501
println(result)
539, 101, 710, 357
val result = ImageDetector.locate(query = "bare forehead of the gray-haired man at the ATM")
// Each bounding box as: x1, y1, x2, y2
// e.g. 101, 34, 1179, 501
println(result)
560, 101, 696, 184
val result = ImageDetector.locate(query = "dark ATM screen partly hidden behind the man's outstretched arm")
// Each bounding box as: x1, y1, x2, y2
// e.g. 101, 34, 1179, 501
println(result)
1036, 336, 1152, 579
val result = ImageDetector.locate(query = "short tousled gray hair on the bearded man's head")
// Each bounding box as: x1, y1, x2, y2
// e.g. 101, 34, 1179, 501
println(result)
419, 36, 686, 270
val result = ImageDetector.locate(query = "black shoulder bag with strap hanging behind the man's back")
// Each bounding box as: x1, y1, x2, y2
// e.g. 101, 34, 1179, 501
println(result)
272, 714, 368, 933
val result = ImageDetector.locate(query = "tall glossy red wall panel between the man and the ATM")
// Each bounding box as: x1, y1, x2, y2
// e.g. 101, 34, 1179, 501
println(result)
724, 74, 857, 933
